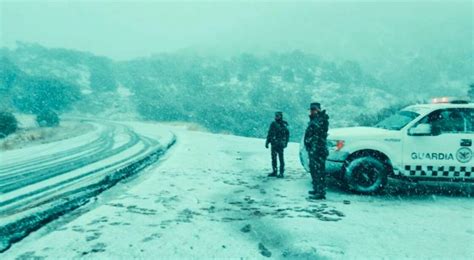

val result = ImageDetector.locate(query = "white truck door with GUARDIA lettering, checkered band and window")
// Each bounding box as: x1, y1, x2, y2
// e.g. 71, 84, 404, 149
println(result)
403, 108, 474, 179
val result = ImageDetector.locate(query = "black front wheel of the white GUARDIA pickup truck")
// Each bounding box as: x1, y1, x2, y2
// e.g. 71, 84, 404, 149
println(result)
344, 156, 388, 194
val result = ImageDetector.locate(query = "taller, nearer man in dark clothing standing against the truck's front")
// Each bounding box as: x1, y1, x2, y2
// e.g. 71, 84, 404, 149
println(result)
304, 103, 329, 200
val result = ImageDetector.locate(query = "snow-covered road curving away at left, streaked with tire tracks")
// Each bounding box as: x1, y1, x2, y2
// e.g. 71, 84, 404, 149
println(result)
0, 121, 176, 253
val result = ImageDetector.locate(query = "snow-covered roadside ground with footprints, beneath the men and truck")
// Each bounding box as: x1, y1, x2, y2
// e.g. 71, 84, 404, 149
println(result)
2, 123, 474, 259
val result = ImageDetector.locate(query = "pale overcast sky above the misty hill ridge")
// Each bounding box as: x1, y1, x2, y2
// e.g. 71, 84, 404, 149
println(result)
0, 0, 474, 60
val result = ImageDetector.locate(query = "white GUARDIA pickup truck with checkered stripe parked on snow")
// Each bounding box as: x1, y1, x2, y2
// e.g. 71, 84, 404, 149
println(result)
300, 97, 474, 194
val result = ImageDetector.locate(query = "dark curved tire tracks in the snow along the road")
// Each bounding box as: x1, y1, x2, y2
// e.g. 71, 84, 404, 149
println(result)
0, 119, 175, 252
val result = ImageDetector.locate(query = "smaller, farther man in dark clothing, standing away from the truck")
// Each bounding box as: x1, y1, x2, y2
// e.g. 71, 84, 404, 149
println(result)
265, 112, 290, 178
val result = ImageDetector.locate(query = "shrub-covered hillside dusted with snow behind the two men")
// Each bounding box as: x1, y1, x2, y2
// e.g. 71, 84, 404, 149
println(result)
0, 43, 470, 140
